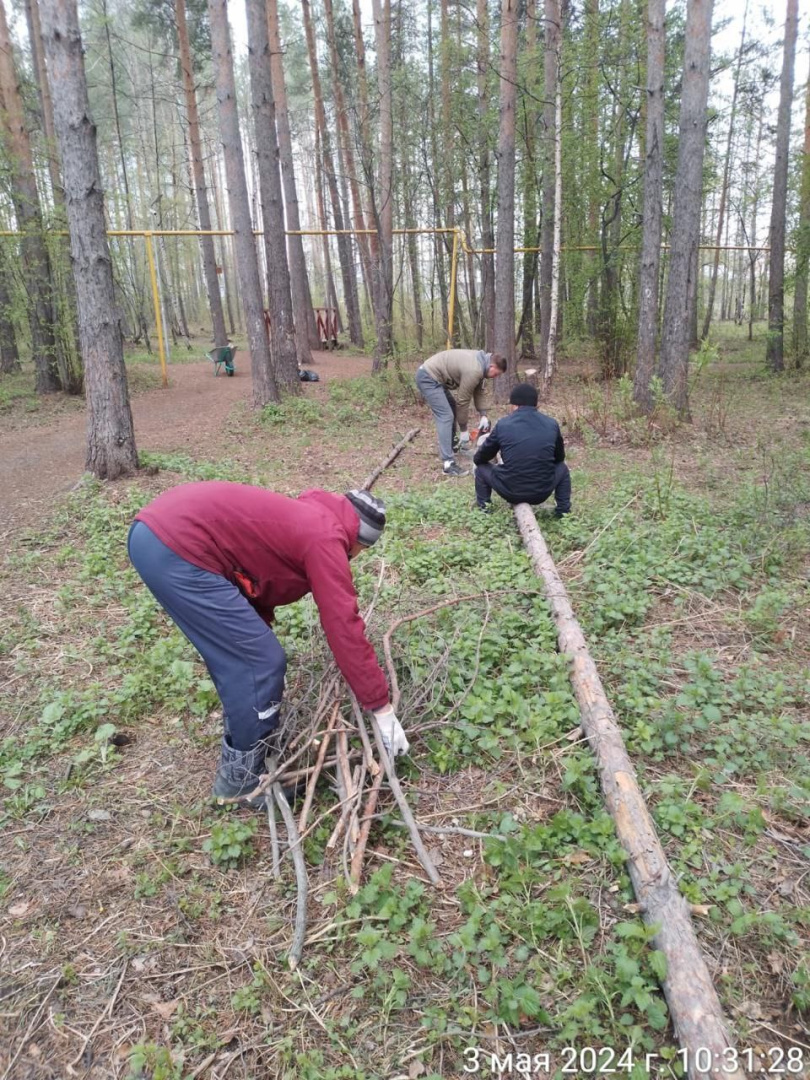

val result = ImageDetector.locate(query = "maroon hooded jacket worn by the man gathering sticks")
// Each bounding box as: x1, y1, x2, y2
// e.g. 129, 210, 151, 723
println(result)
136, 481, 389, 708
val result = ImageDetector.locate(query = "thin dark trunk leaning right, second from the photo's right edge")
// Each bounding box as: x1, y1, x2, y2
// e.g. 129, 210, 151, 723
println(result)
766, 0, 799, 372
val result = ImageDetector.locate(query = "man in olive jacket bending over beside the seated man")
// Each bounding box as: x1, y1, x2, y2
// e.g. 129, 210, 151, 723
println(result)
416, 349, 507, 476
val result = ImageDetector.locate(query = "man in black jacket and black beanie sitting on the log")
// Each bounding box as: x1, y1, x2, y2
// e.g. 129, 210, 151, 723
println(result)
473, 382, 571, 517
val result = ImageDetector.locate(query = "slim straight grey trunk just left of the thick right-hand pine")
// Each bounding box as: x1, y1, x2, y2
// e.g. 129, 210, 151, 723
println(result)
633, 0, 665, 413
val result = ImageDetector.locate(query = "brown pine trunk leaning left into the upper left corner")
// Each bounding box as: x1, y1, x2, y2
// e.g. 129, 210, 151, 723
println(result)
0, 2, 62, 394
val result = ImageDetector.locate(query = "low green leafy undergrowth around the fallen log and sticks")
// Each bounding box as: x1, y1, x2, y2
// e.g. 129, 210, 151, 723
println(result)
0, 444, 810, 1080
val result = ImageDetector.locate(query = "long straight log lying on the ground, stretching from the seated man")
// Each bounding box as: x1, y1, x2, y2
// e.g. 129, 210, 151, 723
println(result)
514, 503, 745, 1080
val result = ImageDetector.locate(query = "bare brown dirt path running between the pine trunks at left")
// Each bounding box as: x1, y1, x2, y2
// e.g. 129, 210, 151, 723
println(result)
0, 352, 372, 536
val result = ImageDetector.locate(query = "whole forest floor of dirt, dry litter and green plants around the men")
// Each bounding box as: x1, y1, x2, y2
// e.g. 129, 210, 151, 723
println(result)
0, 329, 810, 1080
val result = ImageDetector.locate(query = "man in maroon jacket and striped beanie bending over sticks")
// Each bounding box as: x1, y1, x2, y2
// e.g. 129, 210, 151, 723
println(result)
127, 481, 408, 797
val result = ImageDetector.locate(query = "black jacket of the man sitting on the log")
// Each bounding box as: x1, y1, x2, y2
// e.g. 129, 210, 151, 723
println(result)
473, 405, 565, 502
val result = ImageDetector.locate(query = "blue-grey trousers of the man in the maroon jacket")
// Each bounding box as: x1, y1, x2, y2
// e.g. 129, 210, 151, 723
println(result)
127, 522, 287, 750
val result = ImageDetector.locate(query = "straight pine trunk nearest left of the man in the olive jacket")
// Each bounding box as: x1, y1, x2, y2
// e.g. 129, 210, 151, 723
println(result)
372, 0, 394, 372
